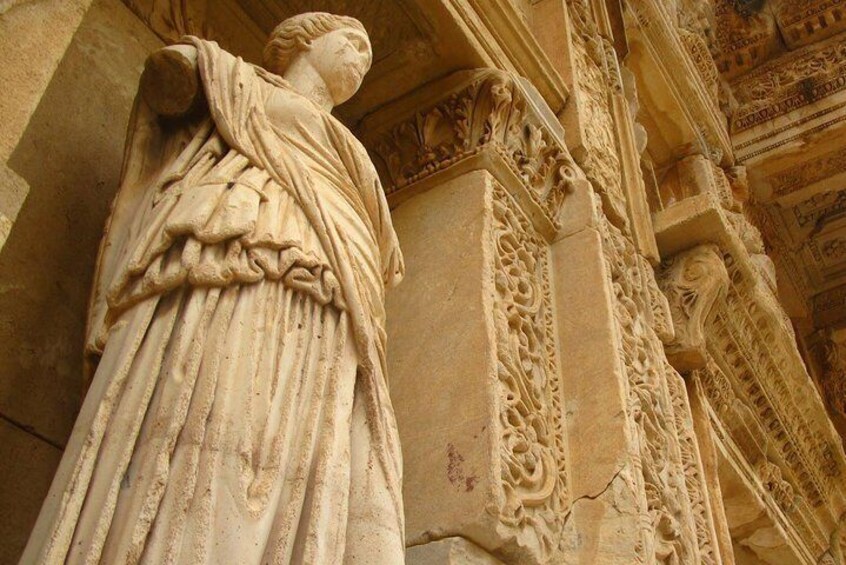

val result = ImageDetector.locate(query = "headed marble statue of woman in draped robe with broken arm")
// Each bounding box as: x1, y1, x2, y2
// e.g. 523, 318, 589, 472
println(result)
23, 13, 404, 565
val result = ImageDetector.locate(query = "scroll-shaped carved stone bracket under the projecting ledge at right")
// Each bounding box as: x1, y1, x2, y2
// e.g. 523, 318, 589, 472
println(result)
659, 244, 729, 372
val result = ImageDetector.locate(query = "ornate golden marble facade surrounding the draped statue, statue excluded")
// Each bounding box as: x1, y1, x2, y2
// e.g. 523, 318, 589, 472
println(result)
0, 0, 846, 565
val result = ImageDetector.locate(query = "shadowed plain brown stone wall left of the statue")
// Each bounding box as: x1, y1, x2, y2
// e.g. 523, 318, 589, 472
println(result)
0, 0, 161, 563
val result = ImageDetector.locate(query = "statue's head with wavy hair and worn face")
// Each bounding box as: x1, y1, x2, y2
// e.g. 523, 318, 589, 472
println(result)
264, 12, 373, 105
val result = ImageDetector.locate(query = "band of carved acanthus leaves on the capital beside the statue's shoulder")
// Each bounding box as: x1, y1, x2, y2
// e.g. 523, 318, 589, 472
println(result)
369, 70, 581, 226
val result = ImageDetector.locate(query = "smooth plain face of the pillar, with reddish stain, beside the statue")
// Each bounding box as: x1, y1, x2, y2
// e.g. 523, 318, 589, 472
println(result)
386, 172, 498, 543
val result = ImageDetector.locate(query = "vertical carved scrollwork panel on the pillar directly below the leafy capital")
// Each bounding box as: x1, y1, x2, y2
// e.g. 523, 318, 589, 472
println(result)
489, 184, 567, 562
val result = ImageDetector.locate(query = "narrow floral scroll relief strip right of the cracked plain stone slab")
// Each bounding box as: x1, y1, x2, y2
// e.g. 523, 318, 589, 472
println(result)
601, 214, 715, 563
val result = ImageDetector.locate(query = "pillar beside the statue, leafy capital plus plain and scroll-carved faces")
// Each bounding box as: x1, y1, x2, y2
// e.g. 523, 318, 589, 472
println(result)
362, 70, 585, 563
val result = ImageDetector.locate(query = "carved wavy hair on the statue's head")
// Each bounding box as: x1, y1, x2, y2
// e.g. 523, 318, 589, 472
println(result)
264, 12, 367, 75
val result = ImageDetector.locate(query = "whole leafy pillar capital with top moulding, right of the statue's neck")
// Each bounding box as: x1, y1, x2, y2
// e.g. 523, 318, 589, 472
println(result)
361, 69, 585, 236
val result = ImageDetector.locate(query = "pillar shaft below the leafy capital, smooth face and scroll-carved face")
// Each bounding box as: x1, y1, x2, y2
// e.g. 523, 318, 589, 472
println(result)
387, 166, 567, 563
